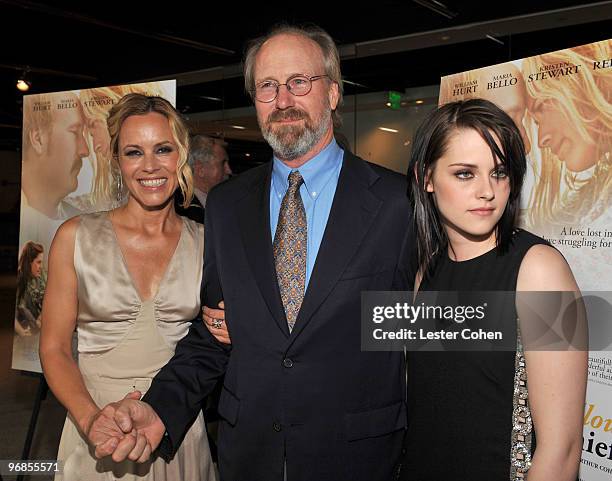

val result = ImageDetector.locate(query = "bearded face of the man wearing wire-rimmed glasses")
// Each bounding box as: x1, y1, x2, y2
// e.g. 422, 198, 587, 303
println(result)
254, 34, 338, 160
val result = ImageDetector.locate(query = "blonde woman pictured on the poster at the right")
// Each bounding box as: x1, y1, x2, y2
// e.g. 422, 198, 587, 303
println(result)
523, 41, 612, 234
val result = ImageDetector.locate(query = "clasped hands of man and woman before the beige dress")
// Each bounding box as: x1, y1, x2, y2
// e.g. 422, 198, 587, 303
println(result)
83, 391, 166, 463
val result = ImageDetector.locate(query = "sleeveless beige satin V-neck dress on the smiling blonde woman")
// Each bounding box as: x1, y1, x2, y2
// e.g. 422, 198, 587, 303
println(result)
55, 212, 216, 481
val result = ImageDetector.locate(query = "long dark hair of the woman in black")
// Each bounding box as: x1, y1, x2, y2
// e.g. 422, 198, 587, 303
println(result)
408, 99, 527, 274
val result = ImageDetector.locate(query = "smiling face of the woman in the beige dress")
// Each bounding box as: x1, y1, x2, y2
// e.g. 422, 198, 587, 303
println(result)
119, 112, 179, 209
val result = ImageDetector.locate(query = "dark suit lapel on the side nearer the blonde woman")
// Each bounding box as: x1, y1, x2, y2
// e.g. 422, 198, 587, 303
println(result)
238, 163, 289, 337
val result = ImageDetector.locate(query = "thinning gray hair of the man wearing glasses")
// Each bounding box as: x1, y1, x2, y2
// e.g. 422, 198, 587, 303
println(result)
244, 24, 343, 127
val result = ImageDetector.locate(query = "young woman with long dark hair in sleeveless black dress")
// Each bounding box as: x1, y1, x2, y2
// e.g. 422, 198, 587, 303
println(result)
401, 99, 587, 481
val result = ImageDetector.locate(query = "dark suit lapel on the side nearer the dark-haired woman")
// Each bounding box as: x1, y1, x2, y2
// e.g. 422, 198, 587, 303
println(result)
291, 153, 382, 338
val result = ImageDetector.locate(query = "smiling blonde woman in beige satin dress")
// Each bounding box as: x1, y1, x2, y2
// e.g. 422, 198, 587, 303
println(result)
40, 94, 215, 481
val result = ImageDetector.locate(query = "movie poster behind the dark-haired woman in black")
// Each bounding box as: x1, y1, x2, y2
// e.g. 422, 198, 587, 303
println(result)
439, 40, 612, 481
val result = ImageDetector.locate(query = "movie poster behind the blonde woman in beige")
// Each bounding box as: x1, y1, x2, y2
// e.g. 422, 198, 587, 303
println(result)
12, 80, 176, 372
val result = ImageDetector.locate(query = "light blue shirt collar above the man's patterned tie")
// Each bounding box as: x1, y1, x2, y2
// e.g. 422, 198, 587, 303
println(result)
272, 139, 342, 198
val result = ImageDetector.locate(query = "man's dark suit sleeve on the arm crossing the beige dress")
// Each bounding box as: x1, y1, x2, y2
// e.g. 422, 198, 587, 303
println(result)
143, 193, 230, 460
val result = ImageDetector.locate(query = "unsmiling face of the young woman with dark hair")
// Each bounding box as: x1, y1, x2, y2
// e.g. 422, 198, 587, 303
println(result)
426, 129, 510, 242
